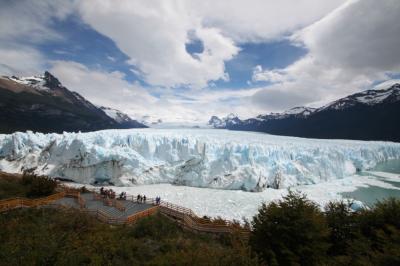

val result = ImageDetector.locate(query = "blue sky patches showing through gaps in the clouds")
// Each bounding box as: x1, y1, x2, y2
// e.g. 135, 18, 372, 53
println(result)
36, 15, 306, 90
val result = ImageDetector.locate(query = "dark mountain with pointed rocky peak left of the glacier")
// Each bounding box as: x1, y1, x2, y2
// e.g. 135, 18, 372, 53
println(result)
0, 71, 147, 133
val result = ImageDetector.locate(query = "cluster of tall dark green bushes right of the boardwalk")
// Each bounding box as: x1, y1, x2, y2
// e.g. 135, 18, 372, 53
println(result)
250, 192, 400, 265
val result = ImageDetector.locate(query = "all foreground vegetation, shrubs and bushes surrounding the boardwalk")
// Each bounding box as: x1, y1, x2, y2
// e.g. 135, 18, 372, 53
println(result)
0, 173, 400, 265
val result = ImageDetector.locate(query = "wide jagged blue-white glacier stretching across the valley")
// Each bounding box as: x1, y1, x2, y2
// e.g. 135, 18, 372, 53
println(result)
0, 128, 400, 191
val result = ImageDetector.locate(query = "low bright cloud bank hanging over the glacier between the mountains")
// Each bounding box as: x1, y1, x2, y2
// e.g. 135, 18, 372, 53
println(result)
50, 61, 260, 123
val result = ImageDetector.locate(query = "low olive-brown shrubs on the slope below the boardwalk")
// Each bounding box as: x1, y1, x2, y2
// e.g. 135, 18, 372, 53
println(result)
0, 209, 258, 265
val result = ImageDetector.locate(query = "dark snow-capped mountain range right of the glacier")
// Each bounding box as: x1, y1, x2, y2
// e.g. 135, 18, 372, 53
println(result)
208, 84, 400, 142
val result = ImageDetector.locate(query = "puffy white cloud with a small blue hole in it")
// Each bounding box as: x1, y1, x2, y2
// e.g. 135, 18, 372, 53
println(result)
80, 0, 239, 88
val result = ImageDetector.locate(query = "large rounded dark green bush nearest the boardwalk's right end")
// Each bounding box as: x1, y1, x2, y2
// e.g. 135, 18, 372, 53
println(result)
250, 191, 329, 265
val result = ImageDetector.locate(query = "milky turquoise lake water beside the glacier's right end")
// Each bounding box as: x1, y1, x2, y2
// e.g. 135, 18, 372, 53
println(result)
342, 160, 400, 206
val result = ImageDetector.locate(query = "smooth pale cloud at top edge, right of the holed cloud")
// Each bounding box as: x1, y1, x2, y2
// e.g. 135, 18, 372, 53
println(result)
193, 0, 345, 42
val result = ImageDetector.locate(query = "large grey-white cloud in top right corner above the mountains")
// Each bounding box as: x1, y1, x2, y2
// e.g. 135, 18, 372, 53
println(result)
253, 0, 400, 111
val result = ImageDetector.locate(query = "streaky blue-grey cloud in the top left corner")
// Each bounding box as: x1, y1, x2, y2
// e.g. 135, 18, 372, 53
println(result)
0, 0, 72, 75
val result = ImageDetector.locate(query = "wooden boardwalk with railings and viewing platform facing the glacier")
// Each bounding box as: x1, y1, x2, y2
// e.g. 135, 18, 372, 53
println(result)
0, 186, 250, 239
